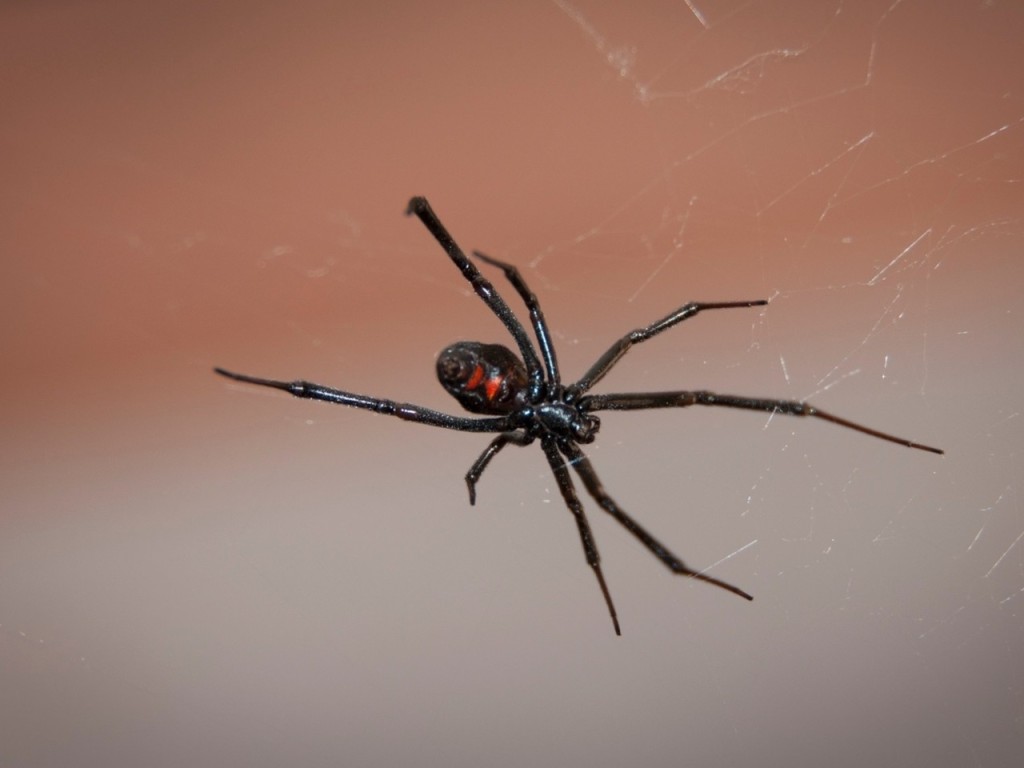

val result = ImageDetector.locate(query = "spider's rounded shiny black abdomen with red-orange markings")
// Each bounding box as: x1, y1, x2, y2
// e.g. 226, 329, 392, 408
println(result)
437, 341, 529, 415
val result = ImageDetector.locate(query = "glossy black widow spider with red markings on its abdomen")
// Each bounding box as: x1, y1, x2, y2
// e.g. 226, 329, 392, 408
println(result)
214, 198, 943, 635
